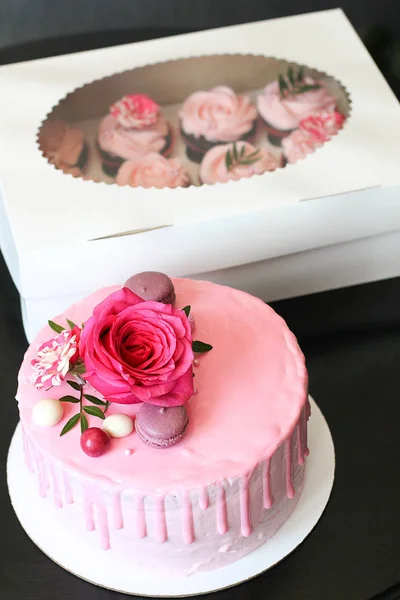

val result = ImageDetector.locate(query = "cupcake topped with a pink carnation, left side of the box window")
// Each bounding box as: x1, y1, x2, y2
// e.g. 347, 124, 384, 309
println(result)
97, 94, 172, 177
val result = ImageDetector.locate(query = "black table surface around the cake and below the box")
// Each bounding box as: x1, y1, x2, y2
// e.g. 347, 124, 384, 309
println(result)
0, 32, 400, 600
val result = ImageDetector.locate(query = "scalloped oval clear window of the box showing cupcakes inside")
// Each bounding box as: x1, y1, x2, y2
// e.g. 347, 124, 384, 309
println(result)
38, 54, 350, 188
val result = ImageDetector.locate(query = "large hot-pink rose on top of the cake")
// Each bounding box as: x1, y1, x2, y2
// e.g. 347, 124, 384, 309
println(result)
80, 288, 193, 406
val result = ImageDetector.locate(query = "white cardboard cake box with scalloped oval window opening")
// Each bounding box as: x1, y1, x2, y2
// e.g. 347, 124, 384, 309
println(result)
0, 10, 400, 338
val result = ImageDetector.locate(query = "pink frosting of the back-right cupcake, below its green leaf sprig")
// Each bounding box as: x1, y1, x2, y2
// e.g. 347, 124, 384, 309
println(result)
257, 77, 337, 130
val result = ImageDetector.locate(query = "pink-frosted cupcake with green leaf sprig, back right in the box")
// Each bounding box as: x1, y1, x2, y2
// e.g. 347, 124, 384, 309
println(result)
257, 67, 337, 146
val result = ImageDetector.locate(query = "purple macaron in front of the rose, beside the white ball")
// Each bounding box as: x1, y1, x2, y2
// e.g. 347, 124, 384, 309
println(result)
135, 402, 189, 449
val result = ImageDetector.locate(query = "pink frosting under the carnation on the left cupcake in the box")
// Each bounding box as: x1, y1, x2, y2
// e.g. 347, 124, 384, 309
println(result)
97, 115, 169, 160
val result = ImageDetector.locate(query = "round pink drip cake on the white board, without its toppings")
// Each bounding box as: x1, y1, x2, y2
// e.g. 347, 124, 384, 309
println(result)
17, 279, 309, 576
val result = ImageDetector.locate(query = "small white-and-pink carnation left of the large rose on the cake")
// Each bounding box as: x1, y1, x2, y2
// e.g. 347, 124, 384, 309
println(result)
31, 325, 81, 389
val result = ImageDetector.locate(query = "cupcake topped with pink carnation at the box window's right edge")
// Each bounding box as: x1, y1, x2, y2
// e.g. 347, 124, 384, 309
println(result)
282, 111, 345, 163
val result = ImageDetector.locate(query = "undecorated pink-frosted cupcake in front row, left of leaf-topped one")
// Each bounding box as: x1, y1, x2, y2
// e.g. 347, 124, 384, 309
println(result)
115, 152, 190, 188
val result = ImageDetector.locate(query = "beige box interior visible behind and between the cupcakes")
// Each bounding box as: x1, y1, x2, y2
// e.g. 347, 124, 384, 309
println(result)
38, 54, 351, 190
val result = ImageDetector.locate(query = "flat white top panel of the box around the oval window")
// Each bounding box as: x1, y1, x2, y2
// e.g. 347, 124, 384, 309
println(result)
0, 9, 400, 298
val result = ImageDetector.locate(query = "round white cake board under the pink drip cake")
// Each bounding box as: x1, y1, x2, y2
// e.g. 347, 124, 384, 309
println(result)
7, 398, 335, 597
